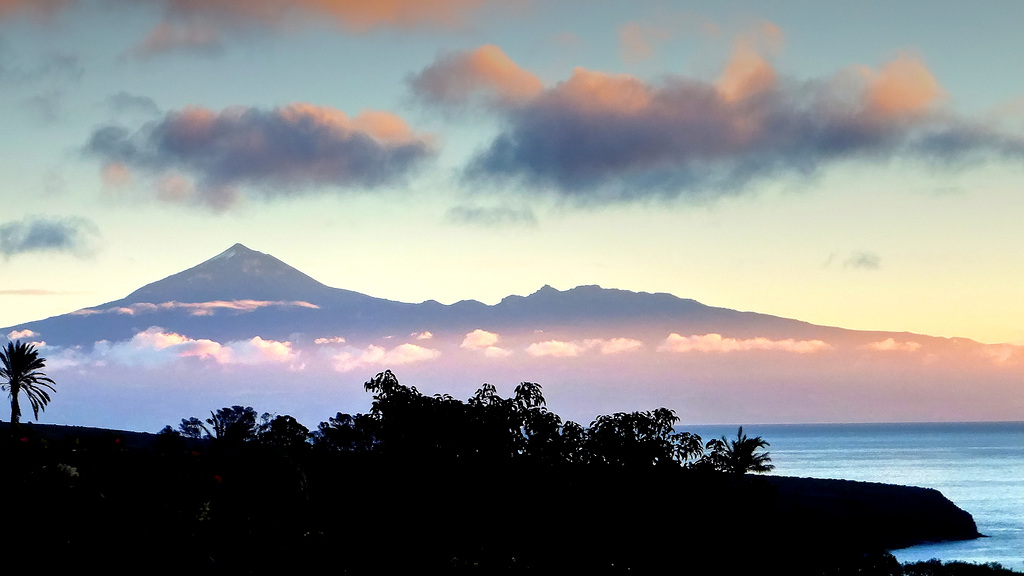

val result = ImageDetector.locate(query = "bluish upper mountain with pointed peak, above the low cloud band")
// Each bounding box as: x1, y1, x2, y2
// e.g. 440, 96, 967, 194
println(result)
2, 239, 905, 346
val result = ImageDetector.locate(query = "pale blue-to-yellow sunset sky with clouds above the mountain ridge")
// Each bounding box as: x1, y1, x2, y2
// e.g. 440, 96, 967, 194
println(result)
0, 0, 1024, 344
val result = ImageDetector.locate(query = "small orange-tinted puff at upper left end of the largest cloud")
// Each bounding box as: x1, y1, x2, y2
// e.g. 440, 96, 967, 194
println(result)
409, 44, 544, 105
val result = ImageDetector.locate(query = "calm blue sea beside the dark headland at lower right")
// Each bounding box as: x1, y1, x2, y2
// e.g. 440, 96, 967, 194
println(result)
681, 422, 1024, 572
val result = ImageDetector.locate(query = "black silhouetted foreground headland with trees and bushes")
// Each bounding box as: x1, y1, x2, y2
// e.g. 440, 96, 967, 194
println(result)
0, 372, 1010, 575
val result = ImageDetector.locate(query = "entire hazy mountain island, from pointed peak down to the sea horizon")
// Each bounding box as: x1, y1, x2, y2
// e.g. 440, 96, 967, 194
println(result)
0, 244, 1024, 430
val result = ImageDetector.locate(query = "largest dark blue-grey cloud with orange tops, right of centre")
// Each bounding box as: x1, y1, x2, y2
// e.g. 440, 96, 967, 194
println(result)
412, 39, 1024, 204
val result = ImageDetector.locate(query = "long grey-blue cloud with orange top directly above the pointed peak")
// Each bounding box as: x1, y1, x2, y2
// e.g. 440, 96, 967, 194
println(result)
84, 104, 434, 209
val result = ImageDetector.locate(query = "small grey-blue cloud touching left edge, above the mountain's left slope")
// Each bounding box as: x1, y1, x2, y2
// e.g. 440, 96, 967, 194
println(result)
0, 216, 99, 258
